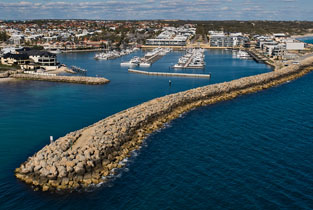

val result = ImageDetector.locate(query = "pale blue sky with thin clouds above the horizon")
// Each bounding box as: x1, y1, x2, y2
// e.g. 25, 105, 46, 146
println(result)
0, 0, 313, 21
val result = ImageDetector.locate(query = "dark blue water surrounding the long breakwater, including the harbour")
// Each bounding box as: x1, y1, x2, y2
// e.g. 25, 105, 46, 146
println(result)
0, 51, 313, 209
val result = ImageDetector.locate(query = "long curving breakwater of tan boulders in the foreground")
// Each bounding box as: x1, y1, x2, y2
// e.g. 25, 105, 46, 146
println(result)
15, 57, 313, 191
